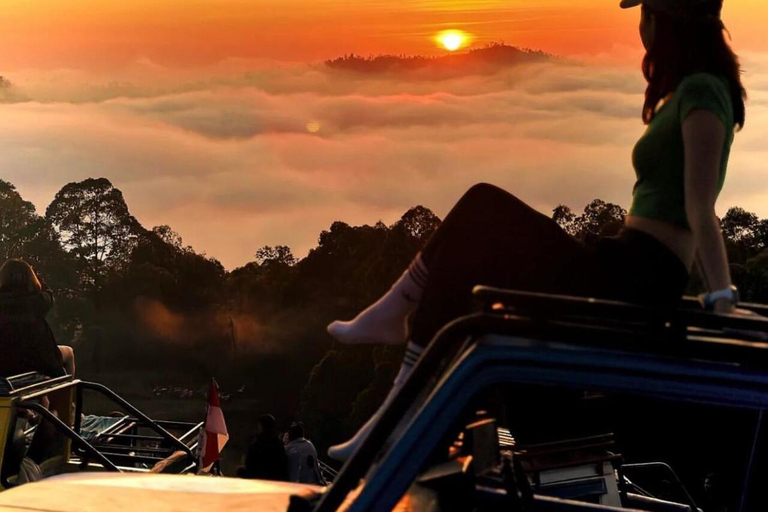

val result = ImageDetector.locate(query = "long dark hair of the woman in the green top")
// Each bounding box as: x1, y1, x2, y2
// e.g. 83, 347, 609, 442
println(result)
643, 4, 747, 128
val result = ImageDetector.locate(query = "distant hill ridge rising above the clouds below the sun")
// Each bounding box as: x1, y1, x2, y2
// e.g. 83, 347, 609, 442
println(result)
325, 43, 556, 74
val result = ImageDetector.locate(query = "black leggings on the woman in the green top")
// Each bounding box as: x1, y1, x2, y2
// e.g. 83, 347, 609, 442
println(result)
411, 184, 688, 346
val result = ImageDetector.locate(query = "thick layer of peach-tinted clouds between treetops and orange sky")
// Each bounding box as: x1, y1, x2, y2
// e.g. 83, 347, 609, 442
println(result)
0, 55, 768, 268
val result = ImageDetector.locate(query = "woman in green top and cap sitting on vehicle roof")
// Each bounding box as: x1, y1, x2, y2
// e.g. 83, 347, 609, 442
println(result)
328, 0, 746, 460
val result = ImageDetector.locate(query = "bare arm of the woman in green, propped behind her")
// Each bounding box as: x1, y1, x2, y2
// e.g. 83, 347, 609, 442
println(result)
683, 110, 731, 312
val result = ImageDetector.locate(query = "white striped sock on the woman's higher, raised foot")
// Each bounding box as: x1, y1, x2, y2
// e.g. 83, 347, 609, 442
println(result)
328, 254, 428, 345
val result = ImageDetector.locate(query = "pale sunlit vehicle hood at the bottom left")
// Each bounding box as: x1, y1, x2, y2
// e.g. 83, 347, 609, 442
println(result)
0, 473, 323, 512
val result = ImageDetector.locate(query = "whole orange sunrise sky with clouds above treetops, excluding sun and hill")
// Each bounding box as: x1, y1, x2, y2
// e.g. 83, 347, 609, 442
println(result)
0, 0, 768, 268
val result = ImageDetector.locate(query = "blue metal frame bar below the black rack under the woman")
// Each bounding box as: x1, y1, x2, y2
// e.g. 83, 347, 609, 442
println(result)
349, 336, 768, 512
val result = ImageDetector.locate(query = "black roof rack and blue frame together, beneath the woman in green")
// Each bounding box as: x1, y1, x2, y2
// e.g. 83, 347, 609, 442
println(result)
314, 287, 768, 512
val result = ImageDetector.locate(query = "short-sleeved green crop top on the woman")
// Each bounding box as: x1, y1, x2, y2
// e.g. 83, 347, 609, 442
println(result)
629, 73, 734, 229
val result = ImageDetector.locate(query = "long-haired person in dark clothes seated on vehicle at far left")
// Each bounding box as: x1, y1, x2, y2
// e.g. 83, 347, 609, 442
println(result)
0, 259, 75, 377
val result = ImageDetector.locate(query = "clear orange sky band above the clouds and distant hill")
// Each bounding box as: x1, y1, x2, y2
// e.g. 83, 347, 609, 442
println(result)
0, 0, 768, 73
